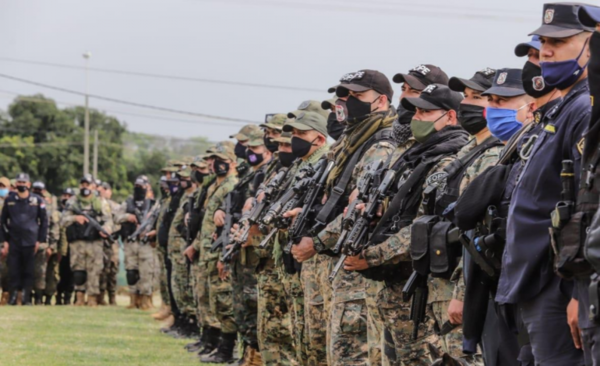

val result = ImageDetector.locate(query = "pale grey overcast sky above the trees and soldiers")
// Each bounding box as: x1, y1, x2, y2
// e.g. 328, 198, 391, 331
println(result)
0, 0, 543, 140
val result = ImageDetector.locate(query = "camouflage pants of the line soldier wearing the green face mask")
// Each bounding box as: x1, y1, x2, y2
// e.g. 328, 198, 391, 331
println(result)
376, 282, 440, 366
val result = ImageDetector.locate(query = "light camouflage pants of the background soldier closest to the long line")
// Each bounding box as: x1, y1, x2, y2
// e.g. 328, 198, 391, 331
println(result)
124, 241, 155, 296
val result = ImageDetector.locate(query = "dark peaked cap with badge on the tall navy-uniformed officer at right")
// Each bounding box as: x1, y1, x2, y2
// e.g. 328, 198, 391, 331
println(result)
529, 3, 594, 38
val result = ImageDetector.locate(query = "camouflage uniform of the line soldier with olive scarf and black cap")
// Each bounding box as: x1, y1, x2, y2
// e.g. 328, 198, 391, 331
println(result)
316, 137, 395, 365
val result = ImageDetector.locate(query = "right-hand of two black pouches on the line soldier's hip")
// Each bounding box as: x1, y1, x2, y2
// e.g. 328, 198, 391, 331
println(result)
428, 221, 462, 280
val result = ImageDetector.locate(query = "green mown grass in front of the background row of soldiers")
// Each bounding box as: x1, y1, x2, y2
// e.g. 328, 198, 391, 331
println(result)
0, 298, 211, 366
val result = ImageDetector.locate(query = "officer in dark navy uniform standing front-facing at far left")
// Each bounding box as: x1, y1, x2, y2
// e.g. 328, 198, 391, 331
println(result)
0, 173, 48, 305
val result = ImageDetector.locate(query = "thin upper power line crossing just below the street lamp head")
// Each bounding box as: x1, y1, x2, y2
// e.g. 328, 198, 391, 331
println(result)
0, 57, 325, 93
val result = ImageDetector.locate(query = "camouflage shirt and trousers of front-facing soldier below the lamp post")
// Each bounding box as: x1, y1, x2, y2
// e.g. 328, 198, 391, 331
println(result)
61, 196, 113, 297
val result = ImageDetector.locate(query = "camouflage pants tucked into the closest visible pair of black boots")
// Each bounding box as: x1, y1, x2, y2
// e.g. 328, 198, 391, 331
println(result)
208, 262, 238, 333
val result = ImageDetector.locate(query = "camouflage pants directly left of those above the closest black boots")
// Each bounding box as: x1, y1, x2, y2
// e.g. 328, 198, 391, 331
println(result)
192, 262, 221, 329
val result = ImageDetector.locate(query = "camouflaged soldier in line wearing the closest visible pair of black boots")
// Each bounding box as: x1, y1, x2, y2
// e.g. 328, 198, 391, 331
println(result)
186, 143, 238, 362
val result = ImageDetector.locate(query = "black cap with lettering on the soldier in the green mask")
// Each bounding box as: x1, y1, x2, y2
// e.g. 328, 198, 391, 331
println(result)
401, 84, 463, 111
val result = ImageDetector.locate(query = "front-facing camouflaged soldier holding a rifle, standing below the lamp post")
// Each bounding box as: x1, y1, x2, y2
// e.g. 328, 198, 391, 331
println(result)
61, 176, 113, 307
